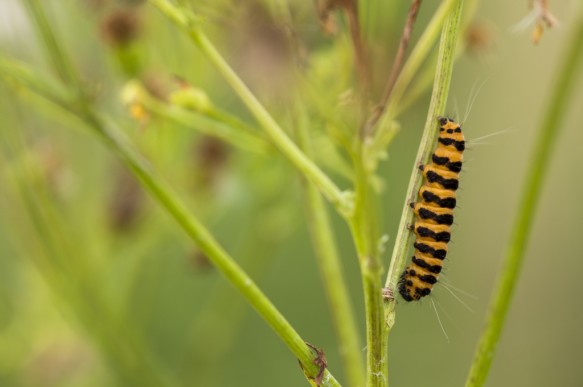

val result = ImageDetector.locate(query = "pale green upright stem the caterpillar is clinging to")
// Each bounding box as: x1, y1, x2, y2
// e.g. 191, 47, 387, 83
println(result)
384, 0, 464, 368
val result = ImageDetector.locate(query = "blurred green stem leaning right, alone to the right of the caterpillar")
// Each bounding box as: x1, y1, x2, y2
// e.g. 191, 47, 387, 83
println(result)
466, 7, 583, 387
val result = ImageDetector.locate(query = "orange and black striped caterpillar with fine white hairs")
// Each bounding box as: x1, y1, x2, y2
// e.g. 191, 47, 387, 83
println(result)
399, 117, 465, 301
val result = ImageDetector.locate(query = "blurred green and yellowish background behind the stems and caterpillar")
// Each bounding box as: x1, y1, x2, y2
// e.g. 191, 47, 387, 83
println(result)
0, 0, 583, 387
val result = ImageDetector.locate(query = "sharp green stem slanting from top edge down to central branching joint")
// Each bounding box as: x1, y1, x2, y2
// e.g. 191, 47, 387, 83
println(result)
150, 0, 353, 216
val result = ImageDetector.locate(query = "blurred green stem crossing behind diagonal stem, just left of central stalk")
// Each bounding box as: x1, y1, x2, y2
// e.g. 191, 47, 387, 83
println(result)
295, 102, 365, 386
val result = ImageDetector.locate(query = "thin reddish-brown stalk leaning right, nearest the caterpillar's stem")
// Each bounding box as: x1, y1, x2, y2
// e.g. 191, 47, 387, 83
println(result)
364, 0, 421, 136
